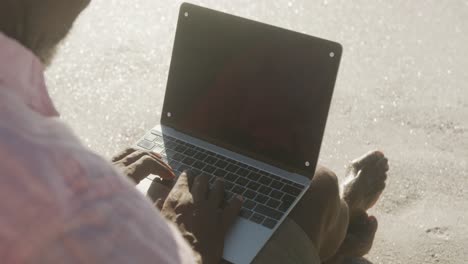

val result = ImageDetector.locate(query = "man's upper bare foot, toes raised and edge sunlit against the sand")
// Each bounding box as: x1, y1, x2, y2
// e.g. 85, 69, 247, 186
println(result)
342, 151, 389, 220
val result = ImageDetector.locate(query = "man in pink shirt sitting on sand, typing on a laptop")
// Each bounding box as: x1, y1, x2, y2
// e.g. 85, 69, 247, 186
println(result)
0, 0, 388, 263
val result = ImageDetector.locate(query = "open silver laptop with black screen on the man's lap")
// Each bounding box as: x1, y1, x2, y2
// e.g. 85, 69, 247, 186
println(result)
135, 3, 342, 264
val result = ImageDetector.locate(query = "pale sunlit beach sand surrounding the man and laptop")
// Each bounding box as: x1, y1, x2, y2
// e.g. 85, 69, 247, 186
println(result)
47, 0, 468, 264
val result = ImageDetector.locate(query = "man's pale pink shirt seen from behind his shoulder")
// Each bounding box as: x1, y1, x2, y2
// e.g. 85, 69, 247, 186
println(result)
0, 33, 194, 263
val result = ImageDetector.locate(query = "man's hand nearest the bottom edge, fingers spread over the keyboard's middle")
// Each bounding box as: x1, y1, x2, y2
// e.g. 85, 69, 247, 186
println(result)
161, 172, 242, 264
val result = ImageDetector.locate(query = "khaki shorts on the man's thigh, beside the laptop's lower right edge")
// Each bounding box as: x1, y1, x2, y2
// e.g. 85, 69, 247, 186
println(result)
252, 218, 320, 264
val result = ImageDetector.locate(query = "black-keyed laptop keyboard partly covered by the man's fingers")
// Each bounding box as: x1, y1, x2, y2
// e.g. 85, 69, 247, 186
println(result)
138, 131, 304, 229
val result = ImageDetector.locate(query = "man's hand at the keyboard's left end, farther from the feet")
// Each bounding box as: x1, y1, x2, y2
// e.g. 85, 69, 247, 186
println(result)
112, 148, 175, 184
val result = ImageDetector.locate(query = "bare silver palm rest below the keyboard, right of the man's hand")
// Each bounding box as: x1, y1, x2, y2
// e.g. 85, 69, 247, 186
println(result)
223, 217, 273, 264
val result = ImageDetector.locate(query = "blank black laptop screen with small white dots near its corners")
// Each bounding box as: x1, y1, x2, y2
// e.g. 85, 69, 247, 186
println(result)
161, 5, 341, 177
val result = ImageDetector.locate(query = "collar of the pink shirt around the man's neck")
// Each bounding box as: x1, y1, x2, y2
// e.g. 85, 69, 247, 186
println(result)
0, 32, 59, 117
